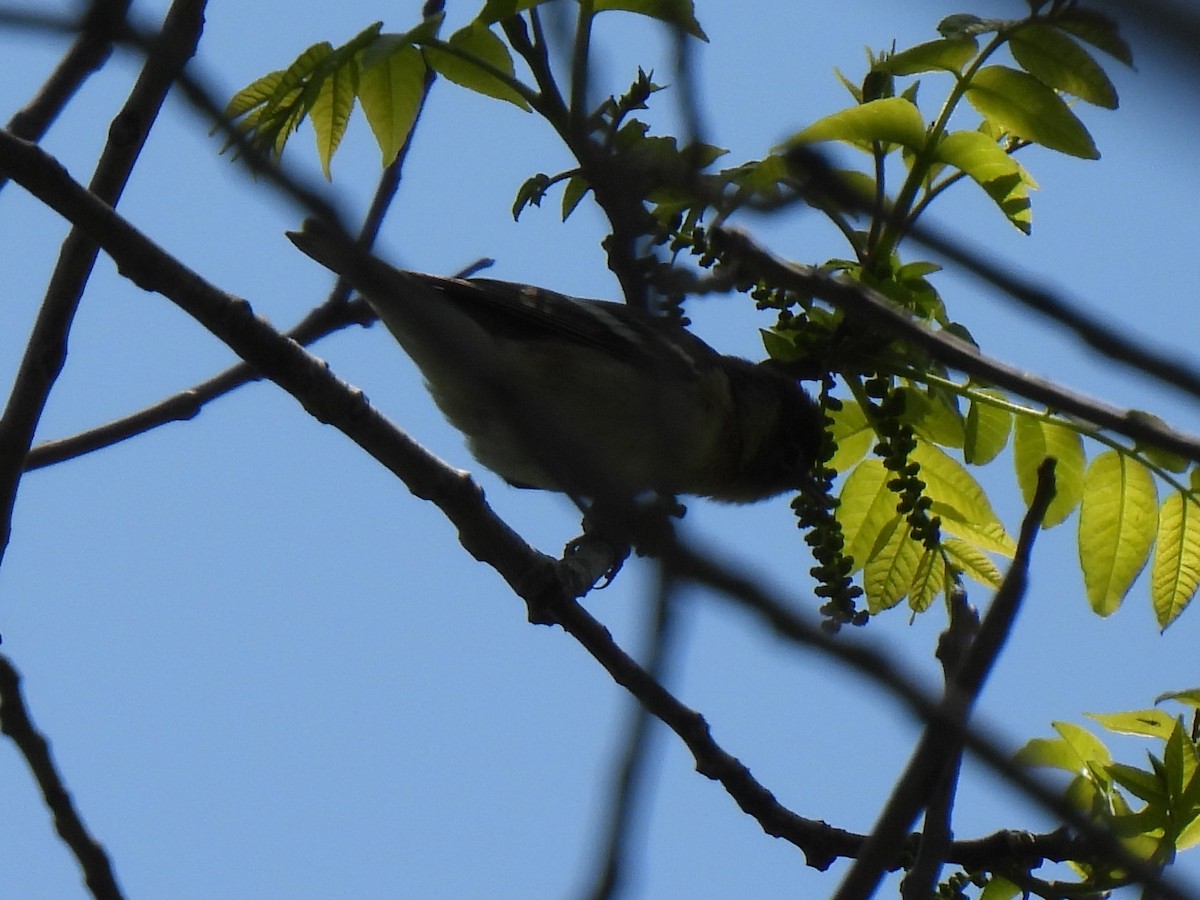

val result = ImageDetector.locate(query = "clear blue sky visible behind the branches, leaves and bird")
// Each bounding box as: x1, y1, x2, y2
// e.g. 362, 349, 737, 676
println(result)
0, 0, 1200, 900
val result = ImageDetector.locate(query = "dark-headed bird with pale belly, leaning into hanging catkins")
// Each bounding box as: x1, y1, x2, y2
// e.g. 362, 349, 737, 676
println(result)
288, 221, 822, 503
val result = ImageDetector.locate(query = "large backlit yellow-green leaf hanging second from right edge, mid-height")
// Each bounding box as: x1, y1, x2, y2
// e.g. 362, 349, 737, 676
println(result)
1079, 450, 1158, 616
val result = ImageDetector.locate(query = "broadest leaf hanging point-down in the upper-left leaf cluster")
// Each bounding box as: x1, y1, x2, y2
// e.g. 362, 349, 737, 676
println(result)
359, 44, 427, 167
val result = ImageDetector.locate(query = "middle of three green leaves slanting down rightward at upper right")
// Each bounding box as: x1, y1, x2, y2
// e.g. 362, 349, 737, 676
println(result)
967, 66, 1100, 160
